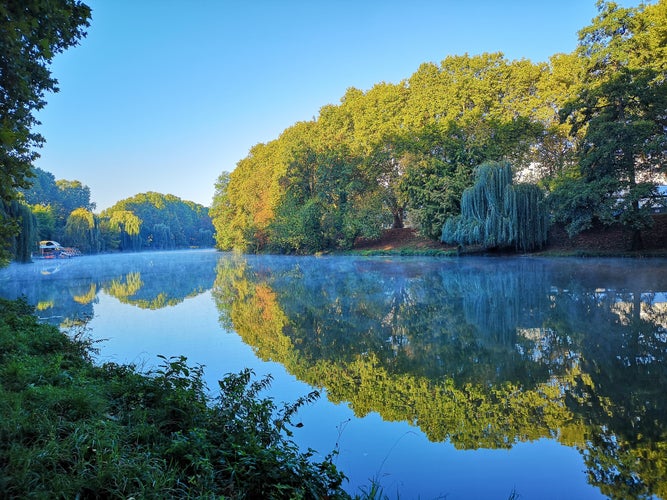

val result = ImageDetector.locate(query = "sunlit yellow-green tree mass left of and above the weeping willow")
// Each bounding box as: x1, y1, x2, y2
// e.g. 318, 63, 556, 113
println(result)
212, 50, 575, 253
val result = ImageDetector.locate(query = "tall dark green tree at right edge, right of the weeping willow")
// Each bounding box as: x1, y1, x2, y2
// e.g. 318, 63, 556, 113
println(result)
554, 0, 667, 249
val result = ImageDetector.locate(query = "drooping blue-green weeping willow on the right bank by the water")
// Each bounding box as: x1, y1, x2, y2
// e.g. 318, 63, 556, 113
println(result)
441, 162, 548, 252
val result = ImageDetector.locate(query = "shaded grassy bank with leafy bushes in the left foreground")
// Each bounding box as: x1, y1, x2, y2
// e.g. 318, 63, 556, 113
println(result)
0, 300, 349, 498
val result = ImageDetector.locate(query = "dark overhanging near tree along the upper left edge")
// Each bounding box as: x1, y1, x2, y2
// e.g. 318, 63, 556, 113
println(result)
0, 0, 90, 264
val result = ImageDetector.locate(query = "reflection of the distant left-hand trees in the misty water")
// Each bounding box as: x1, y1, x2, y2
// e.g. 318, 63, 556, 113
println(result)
0, 252, 218, 325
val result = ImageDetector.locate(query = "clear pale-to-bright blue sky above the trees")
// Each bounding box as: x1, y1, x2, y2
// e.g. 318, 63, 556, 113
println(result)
36, 0, 639, 211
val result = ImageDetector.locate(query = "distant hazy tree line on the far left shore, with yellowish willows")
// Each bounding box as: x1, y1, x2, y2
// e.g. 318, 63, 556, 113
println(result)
8, 168, 214, 261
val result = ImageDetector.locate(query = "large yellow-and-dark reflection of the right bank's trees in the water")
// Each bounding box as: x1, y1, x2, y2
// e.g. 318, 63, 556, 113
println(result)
214, 258, 667, 497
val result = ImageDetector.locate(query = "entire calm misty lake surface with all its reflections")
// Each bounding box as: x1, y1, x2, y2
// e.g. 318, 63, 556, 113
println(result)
0, 251, 667, 499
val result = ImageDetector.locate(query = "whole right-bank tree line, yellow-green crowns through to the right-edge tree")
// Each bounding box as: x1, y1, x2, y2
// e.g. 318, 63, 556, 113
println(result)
211, 0, 667, 253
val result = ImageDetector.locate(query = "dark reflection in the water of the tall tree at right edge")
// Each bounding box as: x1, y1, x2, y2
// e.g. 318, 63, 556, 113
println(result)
554, 289, 667, 498
